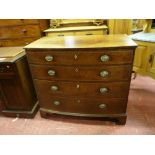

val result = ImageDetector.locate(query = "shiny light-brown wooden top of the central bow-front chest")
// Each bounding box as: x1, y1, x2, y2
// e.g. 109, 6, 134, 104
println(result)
24, 34, 137, 49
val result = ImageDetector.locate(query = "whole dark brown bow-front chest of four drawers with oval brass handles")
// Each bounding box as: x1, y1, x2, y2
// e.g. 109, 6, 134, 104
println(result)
25, 35, 136, 124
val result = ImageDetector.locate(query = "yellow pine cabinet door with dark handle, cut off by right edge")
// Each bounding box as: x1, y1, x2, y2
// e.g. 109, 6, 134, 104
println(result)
147, 47, 155, 74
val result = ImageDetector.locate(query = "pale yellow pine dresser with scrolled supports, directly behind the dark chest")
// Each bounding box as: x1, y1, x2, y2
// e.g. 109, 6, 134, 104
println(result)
44, 19, 108, 37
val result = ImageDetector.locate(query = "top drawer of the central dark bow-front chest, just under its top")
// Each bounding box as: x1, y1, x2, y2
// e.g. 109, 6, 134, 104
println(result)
27, 50, 133, 65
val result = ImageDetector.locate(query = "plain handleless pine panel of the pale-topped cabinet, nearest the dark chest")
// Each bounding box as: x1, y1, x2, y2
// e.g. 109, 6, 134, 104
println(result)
133, 46, 147, 71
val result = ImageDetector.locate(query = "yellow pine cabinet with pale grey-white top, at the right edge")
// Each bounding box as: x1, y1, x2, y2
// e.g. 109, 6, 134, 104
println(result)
130, 32, 155, 79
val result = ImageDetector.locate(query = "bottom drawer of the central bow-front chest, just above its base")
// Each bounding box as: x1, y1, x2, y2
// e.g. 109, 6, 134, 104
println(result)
39, 95, 127, 114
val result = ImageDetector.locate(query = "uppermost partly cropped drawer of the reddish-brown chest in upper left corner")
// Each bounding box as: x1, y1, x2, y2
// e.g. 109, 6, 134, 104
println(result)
0, 19, 38, 26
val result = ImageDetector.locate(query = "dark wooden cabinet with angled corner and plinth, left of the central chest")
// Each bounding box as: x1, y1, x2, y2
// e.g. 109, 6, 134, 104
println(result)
0, 47, 38, 117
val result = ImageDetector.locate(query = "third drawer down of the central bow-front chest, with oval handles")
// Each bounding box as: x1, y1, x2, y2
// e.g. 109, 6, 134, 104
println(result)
34, 80, 129, 98
